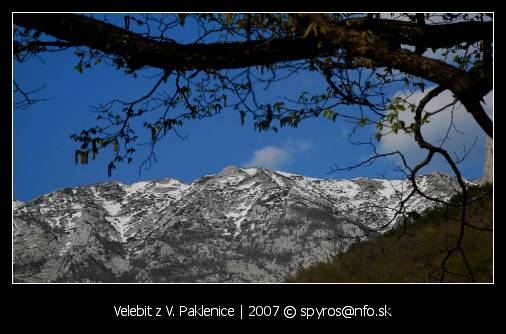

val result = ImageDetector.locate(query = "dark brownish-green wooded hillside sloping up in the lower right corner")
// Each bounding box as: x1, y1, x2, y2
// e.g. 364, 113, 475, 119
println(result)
287, 185, 493, 283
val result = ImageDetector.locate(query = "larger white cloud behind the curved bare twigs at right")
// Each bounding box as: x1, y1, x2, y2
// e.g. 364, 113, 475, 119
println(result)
379, 90, 493, 168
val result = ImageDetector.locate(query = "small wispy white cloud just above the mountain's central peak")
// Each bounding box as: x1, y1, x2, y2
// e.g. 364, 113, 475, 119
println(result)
243, 138, 313, 169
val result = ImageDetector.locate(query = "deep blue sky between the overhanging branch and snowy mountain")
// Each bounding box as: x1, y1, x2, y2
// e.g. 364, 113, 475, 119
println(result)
13, 14, 492, 201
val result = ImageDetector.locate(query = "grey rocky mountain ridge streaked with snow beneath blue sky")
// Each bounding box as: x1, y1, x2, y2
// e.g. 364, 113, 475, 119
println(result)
13, 167, 466, 282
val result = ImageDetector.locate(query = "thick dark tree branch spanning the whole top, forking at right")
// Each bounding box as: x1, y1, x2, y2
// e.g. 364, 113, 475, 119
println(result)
14, 14, 493, 137
